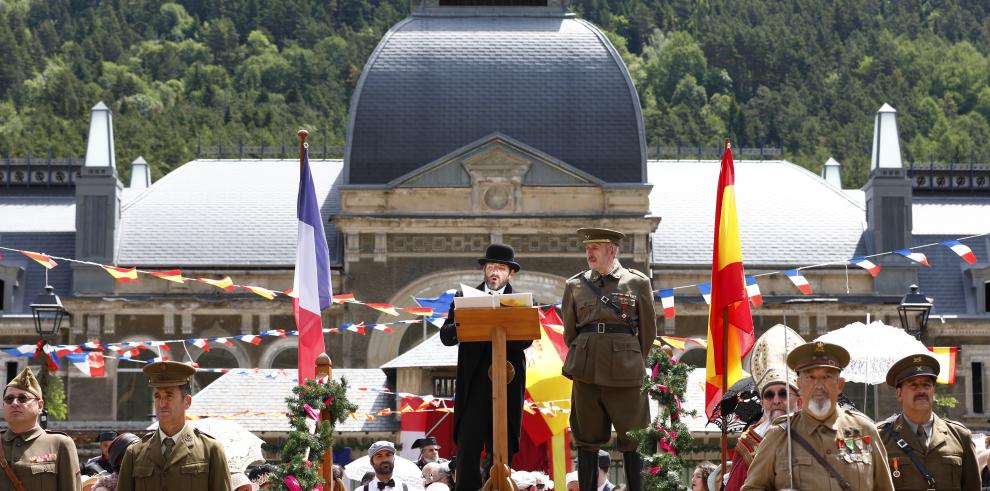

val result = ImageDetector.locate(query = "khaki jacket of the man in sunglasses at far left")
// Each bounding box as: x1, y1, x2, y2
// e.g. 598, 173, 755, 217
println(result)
0, 426, 82, 491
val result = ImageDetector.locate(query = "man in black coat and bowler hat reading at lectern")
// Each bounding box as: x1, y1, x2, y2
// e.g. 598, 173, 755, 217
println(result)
440, 244, 533, 491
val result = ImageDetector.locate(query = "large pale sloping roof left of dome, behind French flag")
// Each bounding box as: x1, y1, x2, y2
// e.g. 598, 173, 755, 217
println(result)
117, 160, 342, 267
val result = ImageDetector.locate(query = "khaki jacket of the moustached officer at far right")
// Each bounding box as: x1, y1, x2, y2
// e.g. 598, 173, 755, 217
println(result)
877, 415, 980, 491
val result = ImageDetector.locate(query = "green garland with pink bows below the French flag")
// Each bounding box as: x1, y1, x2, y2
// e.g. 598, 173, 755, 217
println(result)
269, 378, 357, 491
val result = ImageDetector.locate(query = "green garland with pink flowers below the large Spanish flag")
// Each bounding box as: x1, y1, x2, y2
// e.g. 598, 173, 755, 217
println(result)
630, 347, 695, 491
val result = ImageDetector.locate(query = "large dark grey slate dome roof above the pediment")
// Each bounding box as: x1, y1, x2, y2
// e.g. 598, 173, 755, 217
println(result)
344, 14, 646, 184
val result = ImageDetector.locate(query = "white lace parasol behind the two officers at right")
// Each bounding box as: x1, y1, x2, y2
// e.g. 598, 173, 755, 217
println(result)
815, 321, 930, 385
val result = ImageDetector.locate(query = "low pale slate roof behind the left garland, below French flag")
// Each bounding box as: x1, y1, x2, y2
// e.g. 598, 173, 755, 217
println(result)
188, 368, 399, 432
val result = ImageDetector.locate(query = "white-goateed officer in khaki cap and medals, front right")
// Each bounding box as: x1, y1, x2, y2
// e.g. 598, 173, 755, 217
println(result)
742, 341, 894, 491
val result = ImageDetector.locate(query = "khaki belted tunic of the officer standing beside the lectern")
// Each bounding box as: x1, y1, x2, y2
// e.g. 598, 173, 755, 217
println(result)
561, 266, 657, 387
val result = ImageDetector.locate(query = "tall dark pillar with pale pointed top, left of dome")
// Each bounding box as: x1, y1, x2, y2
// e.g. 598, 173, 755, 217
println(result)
72, 102, 123, 294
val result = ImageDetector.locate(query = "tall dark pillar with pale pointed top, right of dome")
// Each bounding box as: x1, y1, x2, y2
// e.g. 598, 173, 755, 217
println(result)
863, 104, 918, 294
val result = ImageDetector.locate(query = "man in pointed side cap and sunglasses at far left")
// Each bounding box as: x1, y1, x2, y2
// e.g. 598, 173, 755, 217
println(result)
0, 368, 82, 491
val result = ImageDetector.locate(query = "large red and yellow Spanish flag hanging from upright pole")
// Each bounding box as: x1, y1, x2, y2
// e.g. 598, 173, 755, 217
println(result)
705, 139, 755, 418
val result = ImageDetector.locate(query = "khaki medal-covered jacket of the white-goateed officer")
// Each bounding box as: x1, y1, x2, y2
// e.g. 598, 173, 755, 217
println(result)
742, 407, 894, 491
